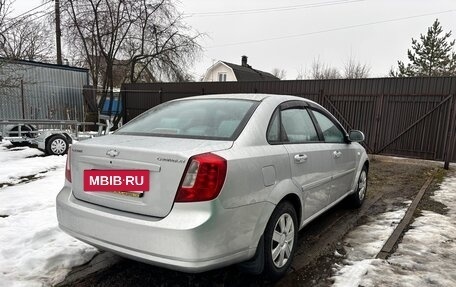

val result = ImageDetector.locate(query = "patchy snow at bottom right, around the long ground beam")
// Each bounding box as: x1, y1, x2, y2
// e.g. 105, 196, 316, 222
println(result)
333, 174, 456, 287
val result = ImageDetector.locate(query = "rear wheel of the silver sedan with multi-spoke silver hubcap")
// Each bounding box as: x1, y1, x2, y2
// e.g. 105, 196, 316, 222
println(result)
263, 201, 299, 281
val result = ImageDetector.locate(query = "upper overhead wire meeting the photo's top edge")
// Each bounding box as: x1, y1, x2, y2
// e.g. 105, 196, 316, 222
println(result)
184, 0, 366, 17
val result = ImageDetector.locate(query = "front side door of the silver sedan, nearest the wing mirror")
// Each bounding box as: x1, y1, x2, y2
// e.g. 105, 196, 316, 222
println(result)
312, 109, 357, 202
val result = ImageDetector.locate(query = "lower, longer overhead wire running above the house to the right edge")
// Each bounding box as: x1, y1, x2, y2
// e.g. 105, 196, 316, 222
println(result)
206, 9, 456, 49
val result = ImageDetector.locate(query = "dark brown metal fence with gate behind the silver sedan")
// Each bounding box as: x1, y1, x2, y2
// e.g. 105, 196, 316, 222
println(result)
122, 77, 456, 162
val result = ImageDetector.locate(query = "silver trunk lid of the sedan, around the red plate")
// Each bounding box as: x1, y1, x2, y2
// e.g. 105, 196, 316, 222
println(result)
71, 135, 233, 217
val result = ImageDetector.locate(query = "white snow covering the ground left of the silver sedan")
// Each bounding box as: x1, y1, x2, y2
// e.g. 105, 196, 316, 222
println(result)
0, 143, 97, 286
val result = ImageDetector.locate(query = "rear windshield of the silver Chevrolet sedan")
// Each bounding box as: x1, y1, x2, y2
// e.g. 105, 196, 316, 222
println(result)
116, 99, 258, 140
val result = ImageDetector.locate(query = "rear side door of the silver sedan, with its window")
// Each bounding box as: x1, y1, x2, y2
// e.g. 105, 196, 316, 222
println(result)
268, 101, 332, 220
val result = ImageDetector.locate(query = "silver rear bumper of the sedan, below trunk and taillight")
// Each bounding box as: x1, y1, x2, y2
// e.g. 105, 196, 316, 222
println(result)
57, 187, 274, 272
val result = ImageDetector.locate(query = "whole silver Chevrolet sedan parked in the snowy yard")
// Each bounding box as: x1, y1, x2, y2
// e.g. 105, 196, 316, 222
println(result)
57, 94, 369, 280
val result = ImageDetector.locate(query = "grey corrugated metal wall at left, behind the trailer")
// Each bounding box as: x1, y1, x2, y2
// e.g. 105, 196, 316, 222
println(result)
0, 59, 88, 121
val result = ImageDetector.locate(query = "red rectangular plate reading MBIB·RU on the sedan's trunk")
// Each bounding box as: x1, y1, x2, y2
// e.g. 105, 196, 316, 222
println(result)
84, 169, 150, 192
